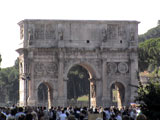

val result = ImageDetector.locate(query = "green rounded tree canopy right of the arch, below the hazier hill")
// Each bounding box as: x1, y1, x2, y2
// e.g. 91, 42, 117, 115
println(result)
138, 38, 160, 71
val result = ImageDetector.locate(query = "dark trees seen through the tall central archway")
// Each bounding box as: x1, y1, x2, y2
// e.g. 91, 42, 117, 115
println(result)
67, 65, 90, 100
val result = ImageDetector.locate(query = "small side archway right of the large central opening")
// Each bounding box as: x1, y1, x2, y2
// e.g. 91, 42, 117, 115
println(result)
110, 82, 125, 108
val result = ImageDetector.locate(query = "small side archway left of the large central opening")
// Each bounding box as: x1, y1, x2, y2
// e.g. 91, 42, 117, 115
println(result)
37, 82, 53, 108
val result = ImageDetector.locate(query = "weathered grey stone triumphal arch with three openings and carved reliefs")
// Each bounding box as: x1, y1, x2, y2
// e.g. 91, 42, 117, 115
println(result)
17, 20, 138, 106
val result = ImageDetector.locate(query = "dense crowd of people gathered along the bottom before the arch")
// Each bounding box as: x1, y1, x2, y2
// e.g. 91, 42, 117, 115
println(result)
0, 106, 147, 120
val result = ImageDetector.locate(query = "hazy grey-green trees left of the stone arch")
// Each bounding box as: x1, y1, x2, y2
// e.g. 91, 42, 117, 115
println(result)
0, 59, 19, 103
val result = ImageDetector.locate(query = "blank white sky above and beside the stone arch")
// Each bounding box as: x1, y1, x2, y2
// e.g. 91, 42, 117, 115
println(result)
0, 0, 160, 68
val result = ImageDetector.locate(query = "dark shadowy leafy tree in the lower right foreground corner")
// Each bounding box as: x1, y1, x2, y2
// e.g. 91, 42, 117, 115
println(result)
136, 78, 160, 120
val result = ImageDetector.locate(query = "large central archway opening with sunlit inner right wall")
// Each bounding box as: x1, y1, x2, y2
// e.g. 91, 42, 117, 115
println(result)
67, 64, 96, 107
